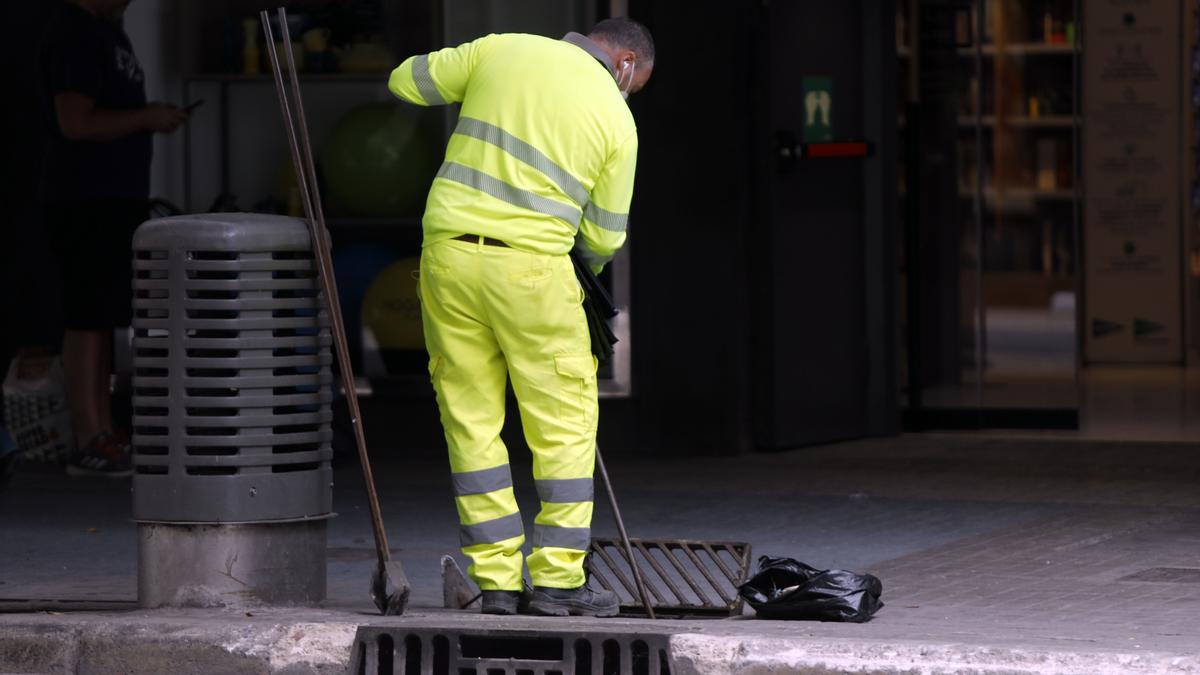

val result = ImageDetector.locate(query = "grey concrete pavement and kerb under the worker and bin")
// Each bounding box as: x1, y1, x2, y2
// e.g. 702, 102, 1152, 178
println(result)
0, 435, 1200, 674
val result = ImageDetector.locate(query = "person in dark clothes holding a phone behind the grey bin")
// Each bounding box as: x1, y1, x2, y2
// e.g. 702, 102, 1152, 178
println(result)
42, 0, 187, 476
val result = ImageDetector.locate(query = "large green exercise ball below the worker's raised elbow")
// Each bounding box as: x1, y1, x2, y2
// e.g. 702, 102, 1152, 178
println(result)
320, 103, 437, 217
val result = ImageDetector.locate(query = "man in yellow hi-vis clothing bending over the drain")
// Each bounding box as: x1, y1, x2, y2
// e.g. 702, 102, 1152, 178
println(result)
388, 18, 654, 616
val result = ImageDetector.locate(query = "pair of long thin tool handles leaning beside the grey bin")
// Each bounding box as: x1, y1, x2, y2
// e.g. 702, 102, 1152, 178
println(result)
259, 7, 391, 561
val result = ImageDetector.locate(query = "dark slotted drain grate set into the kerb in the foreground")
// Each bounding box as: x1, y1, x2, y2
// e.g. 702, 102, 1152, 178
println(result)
349, 626, 671, 675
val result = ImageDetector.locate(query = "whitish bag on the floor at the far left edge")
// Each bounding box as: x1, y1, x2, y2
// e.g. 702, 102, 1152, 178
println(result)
4, 352, 74, 464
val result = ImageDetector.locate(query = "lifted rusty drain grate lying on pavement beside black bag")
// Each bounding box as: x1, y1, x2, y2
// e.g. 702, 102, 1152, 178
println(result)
588, 538, 750, 617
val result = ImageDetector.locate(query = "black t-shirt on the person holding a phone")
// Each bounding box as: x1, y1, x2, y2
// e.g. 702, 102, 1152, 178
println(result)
42, 2, 152, 202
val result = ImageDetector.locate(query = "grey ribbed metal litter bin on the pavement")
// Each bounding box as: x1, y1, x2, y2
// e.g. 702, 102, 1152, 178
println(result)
133, 214, 332, 607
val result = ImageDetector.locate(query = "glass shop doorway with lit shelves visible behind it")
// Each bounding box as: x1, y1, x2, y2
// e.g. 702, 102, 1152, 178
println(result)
896, 0, 1081, 430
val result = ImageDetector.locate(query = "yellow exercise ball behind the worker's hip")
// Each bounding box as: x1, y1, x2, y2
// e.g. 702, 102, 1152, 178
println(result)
362, 257, 425, 350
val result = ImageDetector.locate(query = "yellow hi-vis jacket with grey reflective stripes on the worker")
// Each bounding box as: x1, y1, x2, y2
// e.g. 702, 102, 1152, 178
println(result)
388, 34, 637, 273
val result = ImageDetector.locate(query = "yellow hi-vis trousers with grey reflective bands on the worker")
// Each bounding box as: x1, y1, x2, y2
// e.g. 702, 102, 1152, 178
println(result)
420, 239, 599, 591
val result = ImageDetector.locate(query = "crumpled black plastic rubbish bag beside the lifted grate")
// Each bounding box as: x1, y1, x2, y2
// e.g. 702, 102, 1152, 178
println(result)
738, 555, 883, 623
